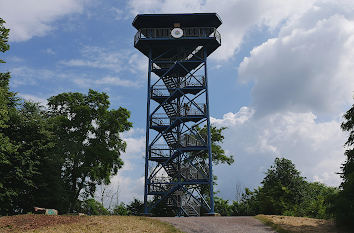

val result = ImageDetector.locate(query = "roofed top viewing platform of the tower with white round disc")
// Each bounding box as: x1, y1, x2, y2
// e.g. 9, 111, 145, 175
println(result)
133, 13, 222, 60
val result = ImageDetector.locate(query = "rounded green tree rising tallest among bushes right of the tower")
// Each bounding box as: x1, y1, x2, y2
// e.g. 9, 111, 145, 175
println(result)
258, 158, 306, 214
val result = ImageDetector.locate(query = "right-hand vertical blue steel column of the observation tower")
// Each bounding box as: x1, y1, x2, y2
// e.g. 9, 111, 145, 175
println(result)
204, 48, 214, 214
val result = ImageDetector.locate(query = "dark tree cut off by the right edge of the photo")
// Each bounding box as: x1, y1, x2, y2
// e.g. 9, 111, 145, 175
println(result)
335, 102, 354, 227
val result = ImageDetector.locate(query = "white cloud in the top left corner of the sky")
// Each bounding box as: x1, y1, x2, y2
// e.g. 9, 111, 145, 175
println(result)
0, 0, 87, 41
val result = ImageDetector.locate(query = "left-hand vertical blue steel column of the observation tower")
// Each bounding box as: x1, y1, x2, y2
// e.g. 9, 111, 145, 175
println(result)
144, 48, 152, 214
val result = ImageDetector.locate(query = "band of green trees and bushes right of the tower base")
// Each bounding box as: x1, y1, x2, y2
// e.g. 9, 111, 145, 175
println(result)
215, 158, 338, 218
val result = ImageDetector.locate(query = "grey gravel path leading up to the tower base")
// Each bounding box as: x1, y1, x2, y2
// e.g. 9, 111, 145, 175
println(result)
154, 217, 275, 233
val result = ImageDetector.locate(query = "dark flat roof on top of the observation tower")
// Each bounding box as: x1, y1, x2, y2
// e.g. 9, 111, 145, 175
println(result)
133, 13, 222, 30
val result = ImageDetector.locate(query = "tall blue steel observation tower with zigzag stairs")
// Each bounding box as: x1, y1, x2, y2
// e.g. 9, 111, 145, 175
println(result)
133, 13, 221, 216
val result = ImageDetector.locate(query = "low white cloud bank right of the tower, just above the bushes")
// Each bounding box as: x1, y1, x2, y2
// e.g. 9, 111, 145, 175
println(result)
212, 107, 345, 199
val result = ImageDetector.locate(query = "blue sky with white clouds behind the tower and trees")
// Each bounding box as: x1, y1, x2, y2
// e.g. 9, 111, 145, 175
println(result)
0, 0, 354, 206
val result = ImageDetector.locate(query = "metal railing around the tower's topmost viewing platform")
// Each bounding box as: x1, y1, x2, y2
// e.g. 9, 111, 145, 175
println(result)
134, 27, 221, 44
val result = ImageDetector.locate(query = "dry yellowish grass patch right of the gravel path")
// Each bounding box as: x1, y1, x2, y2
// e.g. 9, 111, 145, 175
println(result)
255, 214, 343, 233
